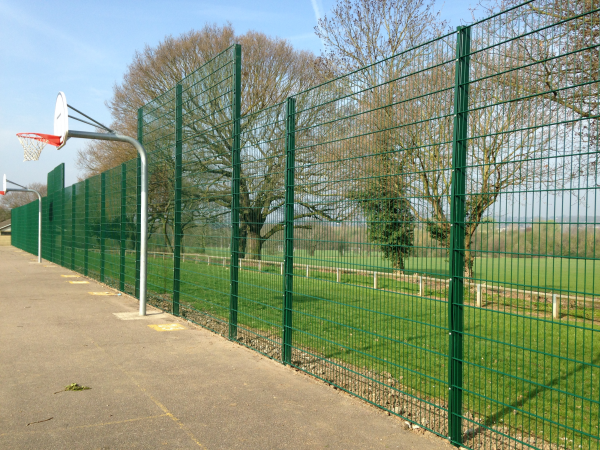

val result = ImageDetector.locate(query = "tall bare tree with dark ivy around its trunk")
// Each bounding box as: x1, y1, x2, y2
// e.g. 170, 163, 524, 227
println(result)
315, 0, 446, 270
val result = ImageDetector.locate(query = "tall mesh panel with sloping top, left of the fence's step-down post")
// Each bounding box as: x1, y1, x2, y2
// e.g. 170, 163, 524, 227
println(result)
173, 47, 235, 335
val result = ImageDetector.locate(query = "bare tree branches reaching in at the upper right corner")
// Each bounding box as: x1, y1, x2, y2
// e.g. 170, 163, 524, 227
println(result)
484, 0, 600, 171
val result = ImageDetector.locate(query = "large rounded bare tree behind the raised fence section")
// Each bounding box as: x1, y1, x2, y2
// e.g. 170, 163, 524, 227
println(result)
79, 25, 344, 259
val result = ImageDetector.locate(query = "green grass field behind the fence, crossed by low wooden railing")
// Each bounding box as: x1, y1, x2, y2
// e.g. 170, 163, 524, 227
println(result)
31, 244, 600, 448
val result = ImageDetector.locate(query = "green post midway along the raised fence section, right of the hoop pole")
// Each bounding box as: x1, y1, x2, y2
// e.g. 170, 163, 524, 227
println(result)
173, 84, 183, 316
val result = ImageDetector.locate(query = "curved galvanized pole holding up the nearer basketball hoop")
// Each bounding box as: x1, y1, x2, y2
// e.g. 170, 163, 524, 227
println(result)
65, 130, 148, 316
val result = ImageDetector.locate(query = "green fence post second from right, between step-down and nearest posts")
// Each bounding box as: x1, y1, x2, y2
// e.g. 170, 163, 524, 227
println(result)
282, 98, 296, 364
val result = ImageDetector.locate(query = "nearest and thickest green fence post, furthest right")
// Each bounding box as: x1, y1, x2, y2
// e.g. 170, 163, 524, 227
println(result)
448, 26, 471, 446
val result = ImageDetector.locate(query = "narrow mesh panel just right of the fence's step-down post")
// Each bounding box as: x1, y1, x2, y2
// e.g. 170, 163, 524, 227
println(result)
238, 103, 286, 359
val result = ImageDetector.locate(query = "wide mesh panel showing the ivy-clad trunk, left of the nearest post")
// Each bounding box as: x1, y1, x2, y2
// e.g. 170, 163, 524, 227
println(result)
292, 23, 456, 436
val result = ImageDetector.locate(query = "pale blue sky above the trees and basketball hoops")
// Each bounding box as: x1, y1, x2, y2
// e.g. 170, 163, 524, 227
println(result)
0, 0, 476, 185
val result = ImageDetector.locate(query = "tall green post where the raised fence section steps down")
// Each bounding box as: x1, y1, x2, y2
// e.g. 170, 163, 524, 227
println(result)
229, 44, 242, 340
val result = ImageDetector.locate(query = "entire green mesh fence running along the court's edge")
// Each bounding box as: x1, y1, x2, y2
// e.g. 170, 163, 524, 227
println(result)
7, 0, 600, 449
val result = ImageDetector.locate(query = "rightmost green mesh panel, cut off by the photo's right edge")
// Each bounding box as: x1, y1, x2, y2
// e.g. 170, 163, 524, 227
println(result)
463, 1, 600, 448
